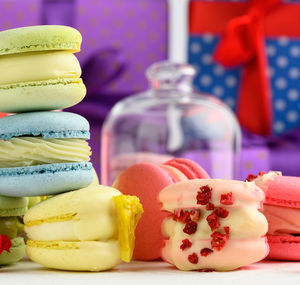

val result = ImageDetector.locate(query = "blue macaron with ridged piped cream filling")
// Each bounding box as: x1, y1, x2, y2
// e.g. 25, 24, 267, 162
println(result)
0, 112, 93, 197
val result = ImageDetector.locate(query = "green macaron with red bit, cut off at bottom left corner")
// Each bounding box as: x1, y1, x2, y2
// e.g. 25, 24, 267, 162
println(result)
0, 196, 28, 265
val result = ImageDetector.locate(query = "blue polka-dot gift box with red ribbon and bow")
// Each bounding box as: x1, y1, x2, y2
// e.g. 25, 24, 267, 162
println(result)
188, 0, 300, 135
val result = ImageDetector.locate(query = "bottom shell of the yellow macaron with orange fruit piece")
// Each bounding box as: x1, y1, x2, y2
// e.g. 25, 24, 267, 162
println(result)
26, 240, 121, 271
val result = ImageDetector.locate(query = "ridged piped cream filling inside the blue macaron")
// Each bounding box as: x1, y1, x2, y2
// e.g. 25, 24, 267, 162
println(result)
0, 137, 91, 168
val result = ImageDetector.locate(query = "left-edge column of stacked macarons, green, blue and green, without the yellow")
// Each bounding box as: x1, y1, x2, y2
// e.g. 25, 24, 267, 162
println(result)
0, 26, 93, 264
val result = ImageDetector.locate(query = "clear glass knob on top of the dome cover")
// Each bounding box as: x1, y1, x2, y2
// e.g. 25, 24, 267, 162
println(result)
146, 61, 196, 92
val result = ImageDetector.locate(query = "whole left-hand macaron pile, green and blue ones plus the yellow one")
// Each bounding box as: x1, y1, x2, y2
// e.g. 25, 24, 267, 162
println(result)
0, 26, 143, 271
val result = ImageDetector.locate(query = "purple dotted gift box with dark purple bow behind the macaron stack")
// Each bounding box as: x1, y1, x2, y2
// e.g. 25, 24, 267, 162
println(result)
0, 0, 168, 172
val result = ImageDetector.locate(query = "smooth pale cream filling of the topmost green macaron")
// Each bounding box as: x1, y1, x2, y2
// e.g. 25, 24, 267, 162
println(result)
0, 51, 81, 85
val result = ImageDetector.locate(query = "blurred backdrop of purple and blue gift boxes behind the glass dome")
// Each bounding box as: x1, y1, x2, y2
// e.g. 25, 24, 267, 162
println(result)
0, 0, 300, 179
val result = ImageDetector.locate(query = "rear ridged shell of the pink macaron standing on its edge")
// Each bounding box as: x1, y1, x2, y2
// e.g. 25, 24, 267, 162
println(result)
164, 158, 210, 179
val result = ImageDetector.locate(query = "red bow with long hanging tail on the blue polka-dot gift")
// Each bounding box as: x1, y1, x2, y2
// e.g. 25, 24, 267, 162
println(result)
215, 0, 281, 134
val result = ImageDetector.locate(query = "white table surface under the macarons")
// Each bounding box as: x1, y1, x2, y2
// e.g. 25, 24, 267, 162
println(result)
0, 260, 300, 285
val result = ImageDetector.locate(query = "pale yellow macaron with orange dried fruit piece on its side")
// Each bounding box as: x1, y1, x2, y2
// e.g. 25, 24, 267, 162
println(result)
24, 185, 143, 271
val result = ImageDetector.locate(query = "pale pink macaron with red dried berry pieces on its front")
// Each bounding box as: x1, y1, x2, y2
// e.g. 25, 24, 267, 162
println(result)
158, 179, 269, 271
